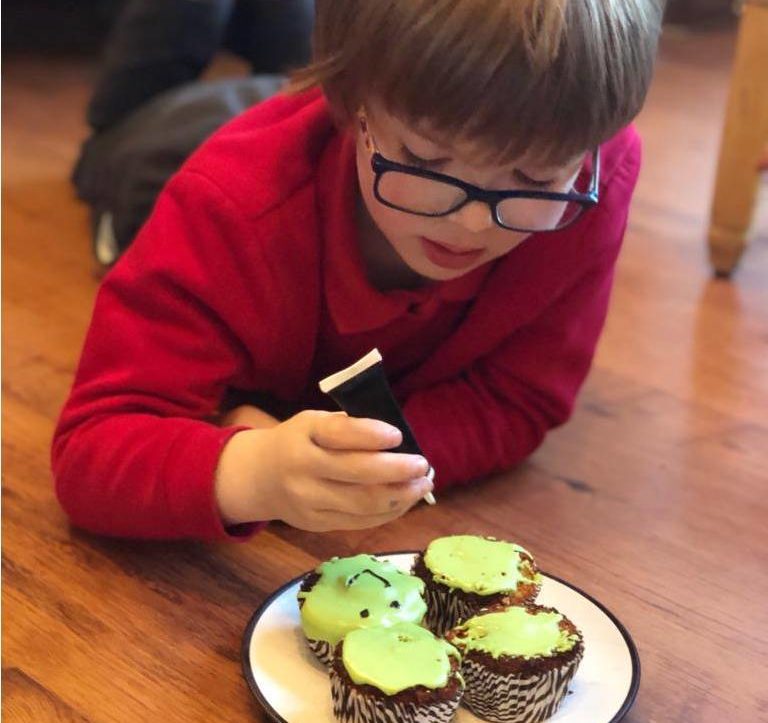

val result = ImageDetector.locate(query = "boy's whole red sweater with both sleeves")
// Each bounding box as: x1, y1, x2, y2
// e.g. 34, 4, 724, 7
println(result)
52, 92, 640, 539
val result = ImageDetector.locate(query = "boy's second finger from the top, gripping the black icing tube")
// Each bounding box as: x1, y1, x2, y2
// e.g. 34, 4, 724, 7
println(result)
317, 449, 429, 485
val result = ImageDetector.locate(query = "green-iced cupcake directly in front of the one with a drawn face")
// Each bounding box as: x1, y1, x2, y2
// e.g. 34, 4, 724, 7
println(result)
329, 623, 464, 723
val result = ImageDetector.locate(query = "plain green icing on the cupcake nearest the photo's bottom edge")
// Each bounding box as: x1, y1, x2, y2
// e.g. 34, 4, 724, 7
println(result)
342, 623, 463, 695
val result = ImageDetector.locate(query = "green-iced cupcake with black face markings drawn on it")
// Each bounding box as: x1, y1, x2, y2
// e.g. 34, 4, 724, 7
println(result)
298, 555, 427, 665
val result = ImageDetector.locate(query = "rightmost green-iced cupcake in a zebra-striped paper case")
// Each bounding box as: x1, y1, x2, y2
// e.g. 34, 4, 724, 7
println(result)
447, 605, 584, 723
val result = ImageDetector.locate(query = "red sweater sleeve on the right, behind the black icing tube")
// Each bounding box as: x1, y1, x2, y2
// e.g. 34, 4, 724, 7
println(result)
405, 204, 626, 489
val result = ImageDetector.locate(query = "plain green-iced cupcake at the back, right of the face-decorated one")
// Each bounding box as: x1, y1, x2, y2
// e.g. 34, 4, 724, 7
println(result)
413, 535, 541, 635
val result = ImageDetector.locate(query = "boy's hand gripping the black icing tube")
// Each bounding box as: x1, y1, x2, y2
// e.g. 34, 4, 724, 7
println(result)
217, 411, 433, 532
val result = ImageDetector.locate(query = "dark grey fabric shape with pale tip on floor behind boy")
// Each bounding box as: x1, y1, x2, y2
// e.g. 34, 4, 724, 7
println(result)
72, 75, 285, 265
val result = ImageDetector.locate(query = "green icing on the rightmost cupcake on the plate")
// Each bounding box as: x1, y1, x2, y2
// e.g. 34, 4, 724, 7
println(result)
455, 606, 579, 658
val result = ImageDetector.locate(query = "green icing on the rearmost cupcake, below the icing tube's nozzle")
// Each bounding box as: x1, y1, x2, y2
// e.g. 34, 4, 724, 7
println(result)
424, 535, 541, 595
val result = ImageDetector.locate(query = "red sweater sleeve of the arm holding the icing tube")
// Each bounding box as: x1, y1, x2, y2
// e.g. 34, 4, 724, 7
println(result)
52, 173, 270, 539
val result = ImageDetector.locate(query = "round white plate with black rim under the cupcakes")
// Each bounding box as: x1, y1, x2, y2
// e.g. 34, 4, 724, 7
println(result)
242, 552, 640, 723
